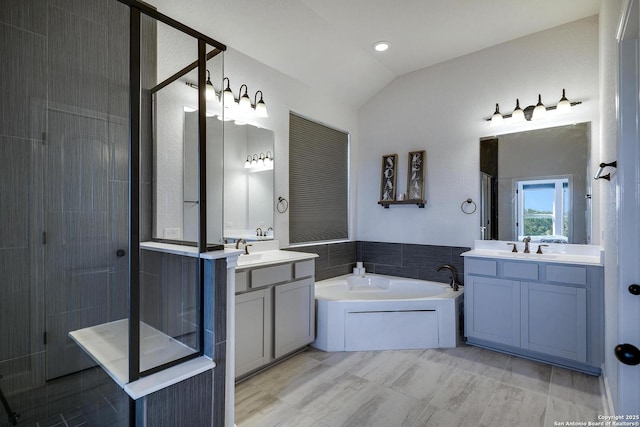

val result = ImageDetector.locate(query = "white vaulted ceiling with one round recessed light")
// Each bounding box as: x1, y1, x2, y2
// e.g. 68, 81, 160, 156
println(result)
151, 0, 600, 107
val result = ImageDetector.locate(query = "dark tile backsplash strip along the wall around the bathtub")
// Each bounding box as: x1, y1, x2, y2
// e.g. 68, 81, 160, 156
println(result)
289, 241, 470, 283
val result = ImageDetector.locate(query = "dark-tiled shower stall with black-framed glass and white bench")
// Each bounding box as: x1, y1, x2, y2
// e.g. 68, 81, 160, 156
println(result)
0, 0, 229, 426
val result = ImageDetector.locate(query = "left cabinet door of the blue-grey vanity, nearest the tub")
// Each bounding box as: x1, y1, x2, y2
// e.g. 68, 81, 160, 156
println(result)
464, 275, 520, 347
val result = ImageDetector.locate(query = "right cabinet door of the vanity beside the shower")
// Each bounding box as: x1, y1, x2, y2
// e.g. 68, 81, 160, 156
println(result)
274, 278, 315, 358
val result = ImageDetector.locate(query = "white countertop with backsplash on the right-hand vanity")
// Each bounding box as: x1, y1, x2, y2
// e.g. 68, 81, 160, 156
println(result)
461, 240, 604, 266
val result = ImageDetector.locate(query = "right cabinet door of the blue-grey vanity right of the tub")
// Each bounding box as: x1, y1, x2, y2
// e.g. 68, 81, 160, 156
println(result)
521, 283, 587, 363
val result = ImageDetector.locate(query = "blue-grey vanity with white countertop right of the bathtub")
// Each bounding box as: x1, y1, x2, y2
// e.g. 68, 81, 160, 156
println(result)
462, 241, 604, 375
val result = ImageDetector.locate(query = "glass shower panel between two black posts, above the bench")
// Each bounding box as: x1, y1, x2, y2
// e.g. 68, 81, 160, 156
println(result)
139, 17, 201, 375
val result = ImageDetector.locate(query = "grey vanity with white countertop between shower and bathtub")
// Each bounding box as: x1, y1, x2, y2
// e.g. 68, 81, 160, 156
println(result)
235, 242, 317, 378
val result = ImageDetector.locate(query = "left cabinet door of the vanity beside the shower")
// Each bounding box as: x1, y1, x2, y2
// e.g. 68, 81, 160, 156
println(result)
235, 288, 271, 377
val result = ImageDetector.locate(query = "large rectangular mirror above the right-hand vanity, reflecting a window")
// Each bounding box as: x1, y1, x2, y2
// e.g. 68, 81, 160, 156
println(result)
480, 123, 591, 244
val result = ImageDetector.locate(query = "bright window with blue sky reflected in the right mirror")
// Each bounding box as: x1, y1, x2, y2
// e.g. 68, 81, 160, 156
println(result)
516, 178, 571, 243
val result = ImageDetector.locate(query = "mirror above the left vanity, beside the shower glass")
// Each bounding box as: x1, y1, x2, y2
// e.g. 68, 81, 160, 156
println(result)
183, 111, 274, 243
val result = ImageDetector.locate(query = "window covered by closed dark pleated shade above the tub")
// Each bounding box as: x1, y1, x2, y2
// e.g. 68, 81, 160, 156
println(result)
289, 113, 349, 243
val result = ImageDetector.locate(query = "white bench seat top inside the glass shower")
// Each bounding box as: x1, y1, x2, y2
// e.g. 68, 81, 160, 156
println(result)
69, 319, 215, 399
